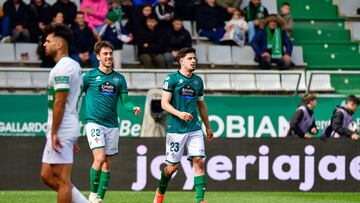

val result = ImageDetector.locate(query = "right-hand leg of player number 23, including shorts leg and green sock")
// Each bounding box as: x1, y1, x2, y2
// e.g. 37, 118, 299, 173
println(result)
187, 130, 206, 202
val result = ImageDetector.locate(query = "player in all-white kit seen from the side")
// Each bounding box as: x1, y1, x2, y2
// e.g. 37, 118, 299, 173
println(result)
41, 25, 88, 203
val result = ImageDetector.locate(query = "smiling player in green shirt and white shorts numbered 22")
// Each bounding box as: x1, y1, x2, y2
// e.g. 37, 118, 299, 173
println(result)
83, 41, 141, 202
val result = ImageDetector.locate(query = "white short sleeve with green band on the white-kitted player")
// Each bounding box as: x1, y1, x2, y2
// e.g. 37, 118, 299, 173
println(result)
54, 67, 71, 92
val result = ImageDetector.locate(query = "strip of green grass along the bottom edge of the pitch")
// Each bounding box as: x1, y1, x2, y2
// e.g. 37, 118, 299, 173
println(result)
0, 191, 360, 203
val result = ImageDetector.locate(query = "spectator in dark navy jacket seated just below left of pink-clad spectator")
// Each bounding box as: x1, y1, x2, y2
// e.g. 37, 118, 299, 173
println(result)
71, 11, 99, 68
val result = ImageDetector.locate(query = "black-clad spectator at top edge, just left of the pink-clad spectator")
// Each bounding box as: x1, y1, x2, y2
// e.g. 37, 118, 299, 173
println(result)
53, 0, 77, 25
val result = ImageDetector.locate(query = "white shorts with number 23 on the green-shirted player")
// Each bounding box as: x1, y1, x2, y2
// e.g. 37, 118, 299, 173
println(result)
166, 130, 205, 164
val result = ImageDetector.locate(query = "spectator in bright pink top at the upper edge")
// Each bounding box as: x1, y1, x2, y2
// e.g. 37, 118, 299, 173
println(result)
80, 0, 108, 33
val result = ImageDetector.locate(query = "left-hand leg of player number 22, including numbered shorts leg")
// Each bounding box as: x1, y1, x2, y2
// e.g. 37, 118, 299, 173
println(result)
86, 123, 105, 202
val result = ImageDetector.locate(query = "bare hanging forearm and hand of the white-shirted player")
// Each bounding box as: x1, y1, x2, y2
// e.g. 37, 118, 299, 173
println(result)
51, 91, 68, 151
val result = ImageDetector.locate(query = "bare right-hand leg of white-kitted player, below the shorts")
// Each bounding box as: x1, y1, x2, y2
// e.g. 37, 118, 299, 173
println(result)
50, 164, 72, 203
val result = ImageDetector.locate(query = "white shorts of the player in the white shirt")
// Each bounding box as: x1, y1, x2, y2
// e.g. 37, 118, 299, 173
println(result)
42, 129, 80, 164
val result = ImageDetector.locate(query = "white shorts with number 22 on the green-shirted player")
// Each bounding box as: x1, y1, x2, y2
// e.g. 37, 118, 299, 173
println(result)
85, 123, 119, 156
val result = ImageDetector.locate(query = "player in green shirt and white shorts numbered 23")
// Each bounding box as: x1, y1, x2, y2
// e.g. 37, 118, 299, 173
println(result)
154, 48, 213, 203
